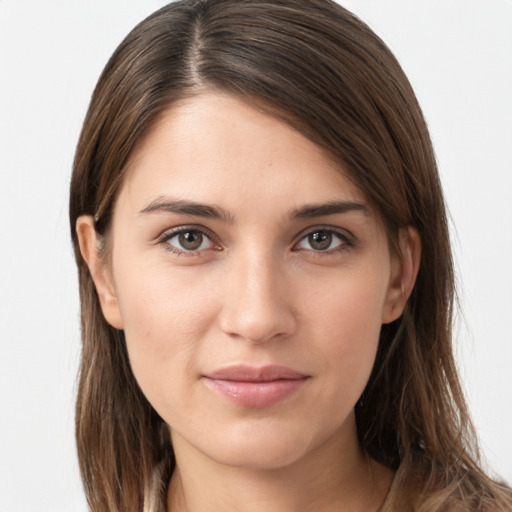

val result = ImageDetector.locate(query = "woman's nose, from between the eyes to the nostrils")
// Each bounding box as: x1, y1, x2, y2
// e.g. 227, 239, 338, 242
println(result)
219, 251, 297, 344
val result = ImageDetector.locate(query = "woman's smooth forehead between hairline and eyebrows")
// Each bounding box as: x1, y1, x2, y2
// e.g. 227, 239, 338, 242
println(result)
119, 93, 372, 219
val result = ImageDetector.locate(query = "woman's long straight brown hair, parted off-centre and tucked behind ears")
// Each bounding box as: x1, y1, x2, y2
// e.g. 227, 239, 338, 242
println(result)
70, 0, 512, 512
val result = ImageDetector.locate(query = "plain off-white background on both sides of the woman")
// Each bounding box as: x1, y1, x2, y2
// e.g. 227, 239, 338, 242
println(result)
0, 0, 512, 512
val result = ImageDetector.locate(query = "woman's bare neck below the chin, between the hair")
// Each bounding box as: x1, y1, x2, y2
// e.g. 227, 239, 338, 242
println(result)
168, 416, 393, 512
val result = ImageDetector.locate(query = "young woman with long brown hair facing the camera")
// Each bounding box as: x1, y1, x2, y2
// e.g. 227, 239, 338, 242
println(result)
70, 0, 512, 512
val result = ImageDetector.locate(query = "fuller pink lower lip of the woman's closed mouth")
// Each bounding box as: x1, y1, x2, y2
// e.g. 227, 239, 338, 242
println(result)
206, 377, 308, 409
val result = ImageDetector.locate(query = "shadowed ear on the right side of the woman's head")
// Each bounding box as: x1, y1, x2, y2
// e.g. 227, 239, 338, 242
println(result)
382, 226, 421, 324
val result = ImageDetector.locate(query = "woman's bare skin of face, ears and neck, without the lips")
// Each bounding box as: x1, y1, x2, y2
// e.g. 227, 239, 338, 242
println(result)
77, 93, 420, 512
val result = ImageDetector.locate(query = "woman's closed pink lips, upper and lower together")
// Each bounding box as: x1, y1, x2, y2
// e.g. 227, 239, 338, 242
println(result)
203, 365, 310, 409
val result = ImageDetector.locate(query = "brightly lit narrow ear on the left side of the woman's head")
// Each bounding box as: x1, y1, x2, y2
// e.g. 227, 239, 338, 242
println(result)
76, 215, 123, 329
